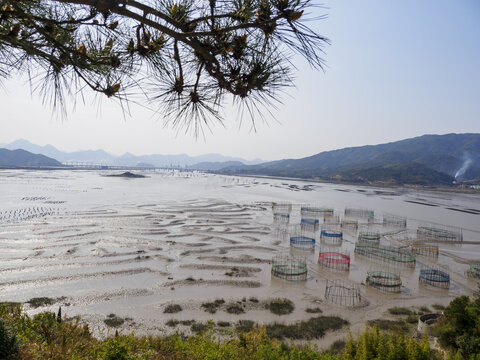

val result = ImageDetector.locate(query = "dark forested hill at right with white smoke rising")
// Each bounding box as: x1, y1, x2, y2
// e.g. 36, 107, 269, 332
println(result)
219, 134, 480, 185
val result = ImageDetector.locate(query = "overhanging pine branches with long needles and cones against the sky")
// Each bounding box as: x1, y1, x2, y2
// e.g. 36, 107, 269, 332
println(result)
0, 0, 328, 135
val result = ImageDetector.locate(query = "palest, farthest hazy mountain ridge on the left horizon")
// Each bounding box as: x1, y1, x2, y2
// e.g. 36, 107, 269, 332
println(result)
0, 139, 262, 170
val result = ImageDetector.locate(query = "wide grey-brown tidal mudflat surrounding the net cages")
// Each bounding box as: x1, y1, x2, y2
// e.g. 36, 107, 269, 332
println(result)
0, 170, 480, 346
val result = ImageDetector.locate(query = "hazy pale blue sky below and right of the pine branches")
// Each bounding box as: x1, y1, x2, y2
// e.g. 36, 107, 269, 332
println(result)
0, 0, 480, 160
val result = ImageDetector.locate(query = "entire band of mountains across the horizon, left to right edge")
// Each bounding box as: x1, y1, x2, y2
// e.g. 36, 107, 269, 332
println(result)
0, 134, 480, 185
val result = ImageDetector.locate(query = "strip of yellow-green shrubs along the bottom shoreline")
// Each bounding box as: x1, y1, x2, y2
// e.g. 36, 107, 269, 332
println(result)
0, 304, 438, 360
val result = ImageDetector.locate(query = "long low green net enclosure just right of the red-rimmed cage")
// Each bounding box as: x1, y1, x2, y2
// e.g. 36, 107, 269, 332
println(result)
355, 242, 415, 267
